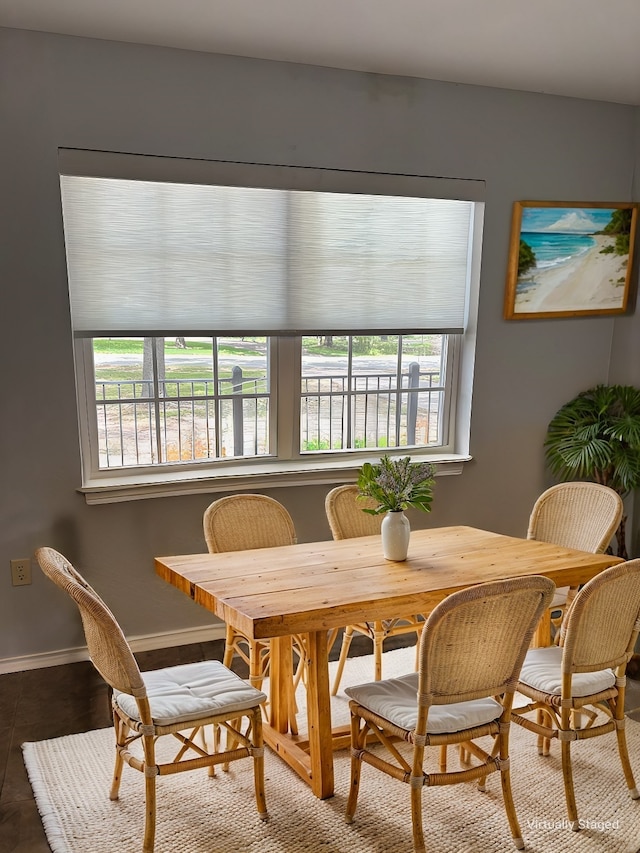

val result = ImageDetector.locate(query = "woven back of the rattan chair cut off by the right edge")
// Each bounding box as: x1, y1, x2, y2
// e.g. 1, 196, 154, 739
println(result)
560, 560, 640, 673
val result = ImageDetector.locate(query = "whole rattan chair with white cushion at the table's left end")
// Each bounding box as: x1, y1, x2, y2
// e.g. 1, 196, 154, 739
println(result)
35, 548, 267, 853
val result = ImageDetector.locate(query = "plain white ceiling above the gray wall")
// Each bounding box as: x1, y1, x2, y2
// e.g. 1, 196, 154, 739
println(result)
0, 0, 640, 105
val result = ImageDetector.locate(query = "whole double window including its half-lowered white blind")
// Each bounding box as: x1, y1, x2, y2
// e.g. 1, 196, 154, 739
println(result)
60, 151, 482, 499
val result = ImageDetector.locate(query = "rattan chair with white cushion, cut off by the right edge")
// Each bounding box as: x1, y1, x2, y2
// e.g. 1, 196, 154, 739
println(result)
511, 560, 640, 830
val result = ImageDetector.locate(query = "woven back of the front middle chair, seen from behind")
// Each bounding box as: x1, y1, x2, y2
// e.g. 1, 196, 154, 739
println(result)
416, 576, 555, 708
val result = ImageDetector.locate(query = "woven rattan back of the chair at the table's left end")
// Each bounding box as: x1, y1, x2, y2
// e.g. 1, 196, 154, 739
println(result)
36, 548, 145, 697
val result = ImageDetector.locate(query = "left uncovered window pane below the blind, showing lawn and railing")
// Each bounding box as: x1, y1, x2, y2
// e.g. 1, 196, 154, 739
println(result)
93, 336, 269, 469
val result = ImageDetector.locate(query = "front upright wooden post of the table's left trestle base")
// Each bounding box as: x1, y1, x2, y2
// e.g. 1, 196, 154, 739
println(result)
307, 631, 333, 799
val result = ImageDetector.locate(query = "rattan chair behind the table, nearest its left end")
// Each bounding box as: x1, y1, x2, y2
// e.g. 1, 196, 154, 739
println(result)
203, 494, 303, 734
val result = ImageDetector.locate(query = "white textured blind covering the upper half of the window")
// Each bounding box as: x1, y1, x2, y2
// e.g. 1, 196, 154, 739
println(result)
61, 151, 480, 336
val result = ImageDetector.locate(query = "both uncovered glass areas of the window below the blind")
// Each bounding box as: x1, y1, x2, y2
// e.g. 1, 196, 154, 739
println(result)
85, 335, 447, 471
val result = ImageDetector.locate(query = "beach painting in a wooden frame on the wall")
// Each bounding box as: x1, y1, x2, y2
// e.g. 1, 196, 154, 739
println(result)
504, 201, 637, 320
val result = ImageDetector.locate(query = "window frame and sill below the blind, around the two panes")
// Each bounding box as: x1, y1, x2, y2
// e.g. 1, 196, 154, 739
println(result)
75, 335, 471, 503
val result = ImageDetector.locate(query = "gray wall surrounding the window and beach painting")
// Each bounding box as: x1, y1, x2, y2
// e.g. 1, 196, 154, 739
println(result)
0, 30, 640, 662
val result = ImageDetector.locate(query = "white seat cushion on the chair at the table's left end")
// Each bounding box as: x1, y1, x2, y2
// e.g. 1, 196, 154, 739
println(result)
114, 660, 267, 726
